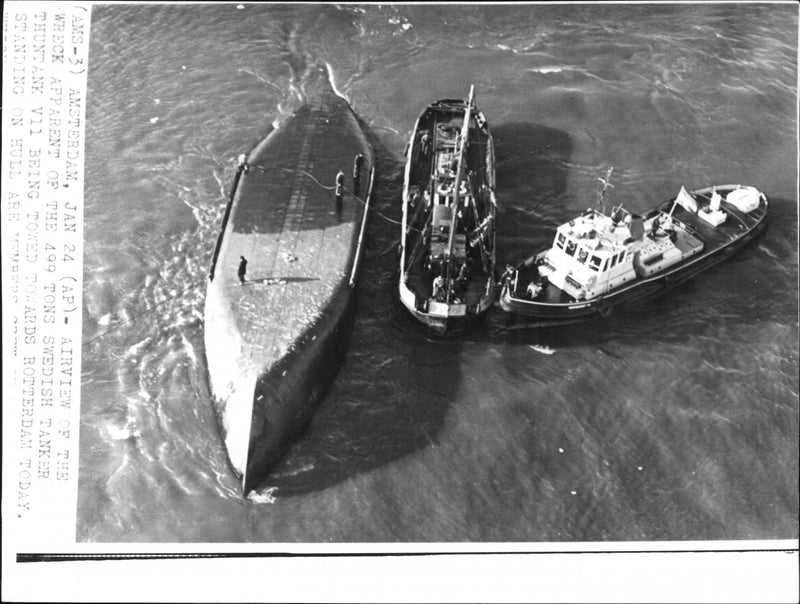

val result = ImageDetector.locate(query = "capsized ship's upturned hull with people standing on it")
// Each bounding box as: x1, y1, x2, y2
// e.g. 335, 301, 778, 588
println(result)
205, 67, 374, 494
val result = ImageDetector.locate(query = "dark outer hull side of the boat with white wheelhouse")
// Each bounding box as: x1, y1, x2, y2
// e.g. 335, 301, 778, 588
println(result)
500, 221, 766, 326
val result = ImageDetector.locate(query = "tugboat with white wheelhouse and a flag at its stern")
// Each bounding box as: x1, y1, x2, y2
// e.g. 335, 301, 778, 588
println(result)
500, 168, 768, 325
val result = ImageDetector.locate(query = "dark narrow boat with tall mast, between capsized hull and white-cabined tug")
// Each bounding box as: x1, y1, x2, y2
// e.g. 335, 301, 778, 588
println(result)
399, 86, 497, 336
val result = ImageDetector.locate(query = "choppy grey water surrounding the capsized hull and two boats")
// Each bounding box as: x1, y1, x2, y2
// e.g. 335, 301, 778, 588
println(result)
78, 4, 798, 542
